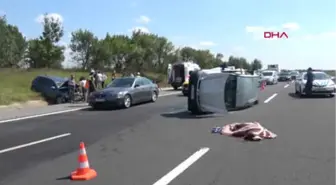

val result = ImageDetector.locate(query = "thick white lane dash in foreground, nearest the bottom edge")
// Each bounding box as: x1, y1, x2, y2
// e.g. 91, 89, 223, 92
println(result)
153, 148, 210, 185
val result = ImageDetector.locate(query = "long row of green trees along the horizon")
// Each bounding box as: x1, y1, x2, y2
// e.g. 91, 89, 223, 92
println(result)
0, 14, 262, 73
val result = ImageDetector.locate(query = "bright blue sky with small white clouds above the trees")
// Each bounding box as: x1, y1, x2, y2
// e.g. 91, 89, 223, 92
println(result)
0, 0, 336, 69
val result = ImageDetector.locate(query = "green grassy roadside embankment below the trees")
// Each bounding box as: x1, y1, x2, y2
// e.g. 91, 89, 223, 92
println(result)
0, 69, 167, 105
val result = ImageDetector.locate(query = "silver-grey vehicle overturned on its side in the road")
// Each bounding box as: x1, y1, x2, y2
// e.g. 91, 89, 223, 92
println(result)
188, 67, 260, 114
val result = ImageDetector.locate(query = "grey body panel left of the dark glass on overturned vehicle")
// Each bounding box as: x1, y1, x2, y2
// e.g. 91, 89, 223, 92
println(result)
198, 73, 230, 113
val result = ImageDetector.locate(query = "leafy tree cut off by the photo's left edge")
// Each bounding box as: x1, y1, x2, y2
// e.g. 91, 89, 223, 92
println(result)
0, 16, 27, 68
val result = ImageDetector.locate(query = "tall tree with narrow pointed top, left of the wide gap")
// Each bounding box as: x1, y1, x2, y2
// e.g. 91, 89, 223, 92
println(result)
26, 14, 65, 68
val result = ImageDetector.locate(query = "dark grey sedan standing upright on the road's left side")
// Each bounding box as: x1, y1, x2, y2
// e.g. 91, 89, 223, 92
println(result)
88, 77, 159, 109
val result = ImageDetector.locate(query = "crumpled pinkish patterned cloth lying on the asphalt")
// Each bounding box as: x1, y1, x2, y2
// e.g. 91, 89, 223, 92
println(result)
212, 122, 277, 141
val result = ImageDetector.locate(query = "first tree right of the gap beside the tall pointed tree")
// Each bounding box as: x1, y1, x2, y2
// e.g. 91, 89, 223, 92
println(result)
69, 29, 98, 69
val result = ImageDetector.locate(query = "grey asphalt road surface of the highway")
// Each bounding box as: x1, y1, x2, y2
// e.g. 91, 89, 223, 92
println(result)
0, 83, 336, 185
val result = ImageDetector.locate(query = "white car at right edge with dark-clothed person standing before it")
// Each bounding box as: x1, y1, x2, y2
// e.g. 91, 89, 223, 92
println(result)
295, 71, 335, 97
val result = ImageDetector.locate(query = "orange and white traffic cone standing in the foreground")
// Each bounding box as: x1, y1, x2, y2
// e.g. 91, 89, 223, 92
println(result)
71, 142, 97, 180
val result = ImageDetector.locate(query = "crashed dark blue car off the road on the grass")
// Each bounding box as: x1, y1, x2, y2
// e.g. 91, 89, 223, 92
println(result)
31, 76, 69, 104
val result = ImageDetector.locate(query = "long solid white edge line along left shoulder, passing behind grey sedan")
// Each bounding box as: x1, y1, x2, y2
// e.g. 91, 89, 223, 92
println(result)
0, 92, 181, 124
